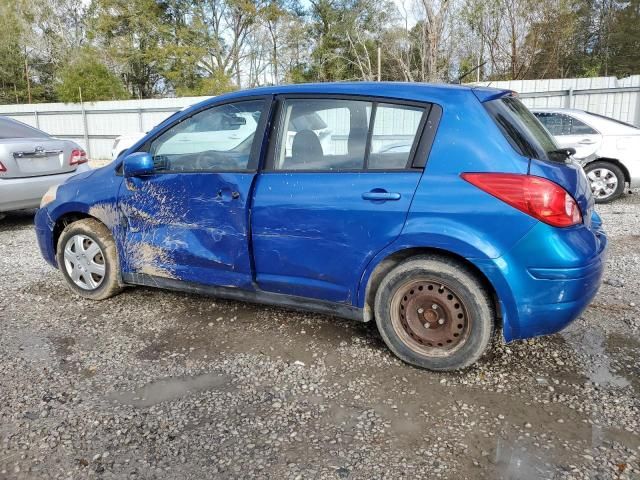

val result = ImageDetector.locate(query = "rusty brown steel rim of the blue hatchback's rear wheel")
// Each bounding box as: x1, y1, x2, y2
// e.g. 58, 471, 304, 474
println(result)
391, 280, 472, 356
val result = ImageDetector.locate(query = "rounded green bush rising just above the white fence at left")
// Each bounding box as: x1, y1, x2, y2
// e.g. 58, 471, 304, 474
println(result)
55, 50, 129, 102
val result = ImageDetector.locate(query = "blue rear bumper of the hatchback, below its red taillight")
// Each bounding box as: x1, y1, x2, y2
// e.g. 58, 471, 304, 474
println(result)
477, 218, 607, 341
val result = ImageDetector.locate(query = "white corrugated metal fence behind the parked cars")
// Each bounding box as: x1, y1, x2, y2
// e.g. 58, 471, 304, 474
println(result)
0, 75, 640, 159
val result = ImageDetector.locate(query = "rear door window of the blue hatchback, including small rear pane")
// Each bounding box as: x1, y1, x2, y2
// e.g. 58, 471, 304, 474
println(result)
273, 99, 425, 171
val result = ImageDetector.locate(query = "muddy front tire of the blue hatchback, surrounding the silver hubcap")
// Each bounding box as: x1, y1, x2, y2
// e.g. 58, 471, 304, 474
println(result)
56, 218, 122, 300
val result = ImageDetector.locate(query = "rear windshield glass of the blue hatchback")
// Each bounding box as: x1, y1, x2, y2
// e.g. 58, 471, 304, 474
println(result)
484, 97, 558, 161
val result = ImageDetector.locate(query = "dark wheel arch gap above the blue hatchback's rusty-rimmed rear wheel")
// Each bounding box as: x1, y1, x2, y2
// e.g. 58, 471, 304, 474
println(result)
362, 246, 503, 328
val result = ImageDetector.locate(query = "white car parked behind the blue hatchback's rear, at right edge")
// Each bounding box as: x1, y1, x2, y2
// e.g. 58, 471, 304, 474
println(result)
531, 108, 640, 203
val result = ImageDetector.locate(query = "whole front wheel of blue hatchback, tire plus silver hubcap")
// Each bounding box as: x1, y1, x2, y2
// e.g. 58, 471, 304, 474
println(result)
56, 218, 122, 300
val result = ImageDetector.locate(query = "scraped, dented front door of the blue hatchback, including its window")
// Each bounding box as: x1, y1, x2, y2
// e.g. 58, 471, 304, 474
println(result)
119, 98, 271, 288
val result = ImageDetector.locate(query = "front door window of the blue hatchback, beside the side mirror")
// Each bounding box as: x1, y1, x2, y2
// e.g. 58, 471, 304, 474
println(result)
149, 100, 265, 172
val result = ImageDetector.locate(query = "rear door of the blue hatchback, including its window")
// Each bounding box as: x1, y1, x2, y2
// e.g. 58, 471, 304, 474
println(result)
251, 96, 429, 303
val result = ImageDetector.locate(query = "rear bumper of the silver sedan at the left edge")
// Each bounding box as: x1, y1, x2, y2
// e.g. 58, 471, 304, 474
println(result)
0, 164, 91, 212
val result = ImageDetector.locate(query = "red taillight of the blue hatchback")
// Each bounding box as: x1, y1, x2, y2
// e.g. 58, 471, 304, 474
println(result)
462, 173, 582, 227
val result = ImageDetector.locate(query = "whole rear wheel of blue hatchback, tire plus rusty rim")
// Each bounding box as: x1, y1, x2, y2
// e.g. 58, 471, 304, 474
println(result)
375, 255, 496, 371
